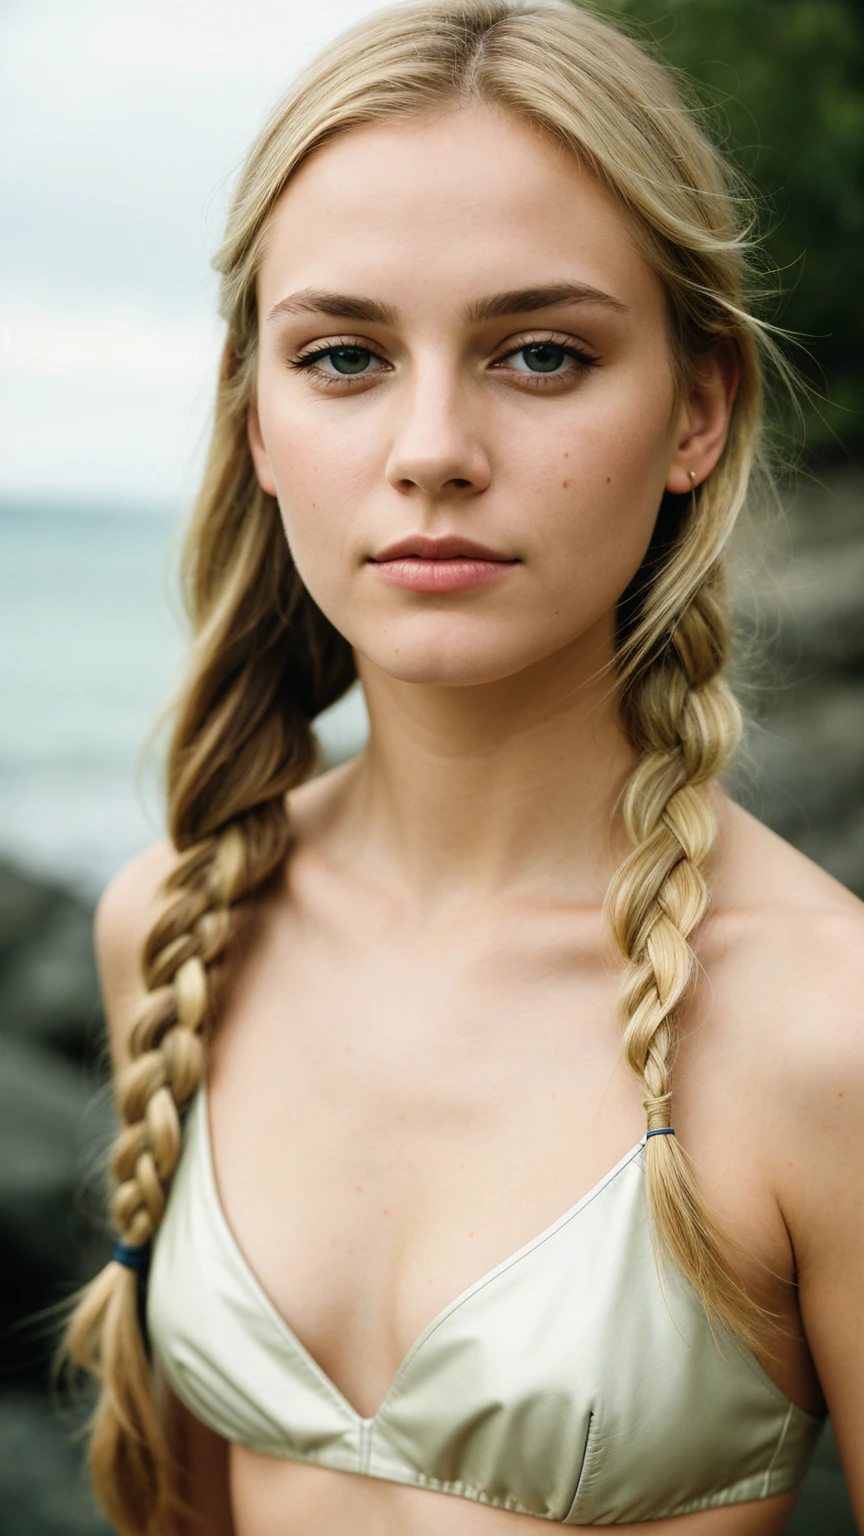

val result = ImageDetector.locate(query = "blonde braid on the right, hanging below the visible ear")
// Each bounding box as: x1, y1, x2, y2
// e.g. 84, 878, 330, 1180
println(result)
607, 561, 772, 1344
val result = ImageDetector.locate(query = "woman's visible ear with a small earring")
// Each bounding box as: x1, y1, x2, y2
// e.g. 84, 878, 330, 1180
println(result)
666, 339, 741, 495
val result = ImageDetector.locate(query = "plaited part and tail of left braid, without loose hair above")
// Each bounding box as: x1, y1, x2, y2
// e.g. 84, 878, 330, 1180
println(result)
68, 802, 287, 1536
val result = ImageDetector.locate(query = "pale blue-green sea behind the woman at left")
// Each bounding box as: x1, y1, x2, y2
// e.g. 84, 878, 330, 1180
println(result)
0, 504, 366, 895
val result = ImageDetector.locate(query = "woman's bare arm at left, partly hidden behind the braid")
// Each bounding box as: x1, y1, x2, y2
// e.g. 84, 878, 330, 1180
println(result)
95, 843, 235, 1536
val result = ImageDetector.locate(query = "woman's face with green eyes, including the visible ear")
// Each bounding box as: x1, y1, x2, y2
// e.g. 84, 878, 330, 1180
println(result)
249, 108, 733, 685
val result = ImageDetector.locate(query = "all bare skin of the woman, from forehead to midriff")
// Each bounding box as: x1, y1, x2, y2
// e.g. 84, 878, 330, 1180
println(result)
104, 108, 864, 1536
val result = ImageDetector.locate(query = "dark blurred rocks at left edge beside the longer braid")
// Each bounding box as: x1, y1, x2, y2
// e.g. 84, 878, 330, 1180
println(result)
0, 863, 112, 1536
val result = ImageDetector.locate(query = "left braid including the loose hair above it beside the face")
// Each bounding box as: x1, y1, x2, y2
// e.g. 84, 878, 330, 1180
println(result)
66, 330, 355, 1536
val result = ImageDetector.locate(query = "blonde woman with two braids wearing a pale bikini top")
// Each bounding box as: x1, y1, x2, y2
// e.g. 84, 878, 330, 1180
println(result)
71, 0, 864, 1536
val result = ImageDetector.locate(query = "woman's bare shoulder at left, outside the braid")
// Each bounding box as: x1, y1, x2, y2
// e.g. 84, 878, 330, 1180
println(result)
94, 840, 177, 1072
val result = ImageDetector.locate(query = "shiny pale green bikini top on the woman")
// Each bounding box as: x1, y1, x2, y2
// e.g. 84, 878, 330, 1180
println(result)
148, 1087, 822, 1525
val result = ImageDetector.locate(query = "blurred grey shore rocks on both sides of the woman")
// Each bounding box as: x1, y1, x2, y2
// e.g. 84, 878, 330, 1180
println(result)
0, 470, 864, 1536
